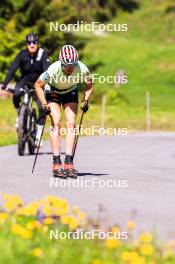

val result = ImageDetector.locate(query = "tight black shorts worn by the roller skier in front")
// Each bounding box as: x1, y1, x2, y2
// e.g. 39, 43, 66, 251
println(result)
45, 89, 78, 105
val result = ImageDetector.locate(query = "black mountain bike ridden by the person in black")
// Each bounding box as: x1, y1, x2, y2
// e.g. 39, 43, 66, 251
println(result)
7, 86, 37, 156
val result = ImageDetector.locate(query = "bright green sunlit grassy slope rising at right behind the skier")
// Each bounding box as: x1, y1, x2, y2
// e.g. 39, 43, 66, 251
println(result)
84, 0, 175, 107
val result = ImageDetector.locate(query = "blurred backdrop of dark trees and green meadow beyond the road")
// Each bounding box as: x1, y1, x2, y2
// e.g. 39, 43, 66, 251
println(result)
0, 0, 175, 145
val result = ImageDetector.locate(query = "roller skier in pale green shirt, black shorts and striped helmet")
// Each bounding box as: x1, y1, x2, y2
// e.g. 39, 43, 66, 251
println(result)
35, 45, 92, 178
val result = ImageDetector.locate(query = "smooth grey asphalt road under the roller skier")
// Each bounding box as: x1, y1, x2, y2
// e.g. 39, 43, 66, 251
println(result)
0, 133, 175, 239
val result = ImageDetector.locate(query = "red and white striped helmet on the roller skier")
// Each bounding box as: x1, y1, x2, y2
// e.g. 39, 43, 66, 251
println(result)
59, 45, 78, 65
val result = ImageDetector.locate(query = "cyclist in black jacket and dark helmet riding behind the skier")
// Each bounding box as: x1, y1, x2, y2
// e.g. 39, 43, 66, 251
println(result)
1, 33, 49, 145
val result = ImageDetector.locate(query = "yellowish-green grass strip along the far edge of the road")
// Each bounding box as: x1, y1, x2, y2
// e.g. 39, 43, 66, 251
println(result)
0, 99, 175, 146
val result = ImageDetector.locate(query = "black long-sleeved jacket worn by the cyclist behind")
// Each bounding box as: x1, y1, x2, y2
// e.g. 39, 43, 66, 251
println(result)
3, 48, 49, 87
